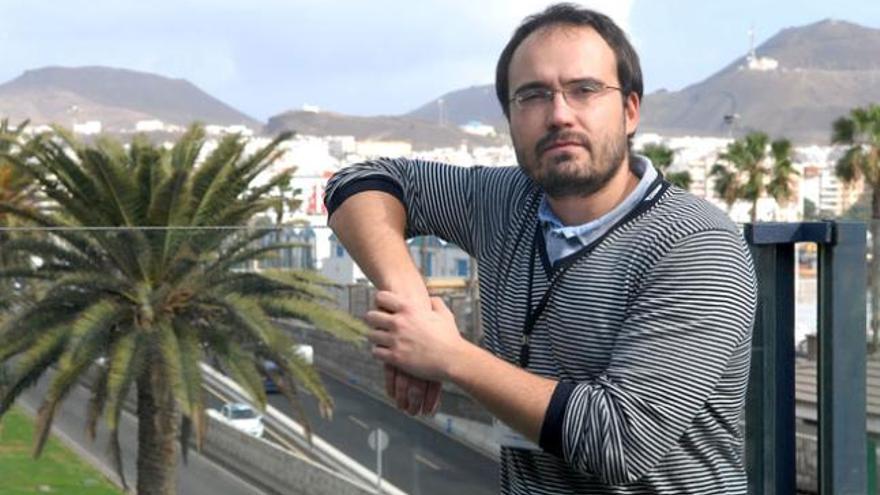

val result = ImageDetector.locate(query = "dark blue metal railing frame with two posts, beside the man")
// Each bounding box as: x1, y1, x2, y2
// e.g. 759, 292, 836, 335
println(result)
744, 221, 867, 495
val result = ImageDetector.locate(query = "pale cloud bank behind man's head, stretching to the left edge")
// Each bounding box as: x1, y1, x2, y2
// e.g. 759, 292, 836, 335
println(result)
0, 0, 633, 118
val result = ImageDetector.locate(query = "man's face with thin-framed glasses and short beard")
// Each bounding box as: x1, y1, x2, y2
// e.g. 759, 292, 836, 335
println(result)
508, 26, 639, 198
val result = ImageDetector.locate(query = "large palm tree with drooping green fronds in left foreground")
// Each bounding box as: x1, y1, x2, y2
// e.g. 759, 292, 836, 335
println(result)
0, 126, 364, 494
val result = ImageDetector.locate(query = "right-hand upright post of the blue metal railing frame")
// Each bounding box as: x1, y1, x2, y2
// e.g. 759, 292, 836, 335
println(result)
818, 223, 867, 495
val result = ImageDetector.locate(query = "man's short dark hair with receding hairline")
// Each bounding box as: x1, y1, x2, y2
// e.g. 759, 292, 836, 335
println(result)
495, 3, 644, 120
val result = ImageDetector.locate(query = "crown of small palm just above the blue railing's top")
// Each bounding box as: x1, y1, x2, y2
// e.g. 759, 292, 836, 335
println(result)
709, 132, 799, 223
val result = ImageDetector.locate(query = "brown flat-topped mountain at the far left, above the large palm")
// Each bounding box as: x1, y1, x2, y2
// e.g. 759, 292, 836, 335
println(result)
0, 67, 261, 131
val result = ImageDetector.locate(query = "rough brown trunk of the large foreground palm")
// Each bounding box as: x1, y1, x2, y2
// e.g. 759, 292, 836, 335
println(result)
137, 356, 178, 495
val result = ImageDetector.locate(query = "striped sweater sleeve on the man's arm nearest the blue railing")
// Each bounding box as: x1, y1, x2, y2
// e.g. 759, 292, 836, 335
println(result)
542, 230, 757, 484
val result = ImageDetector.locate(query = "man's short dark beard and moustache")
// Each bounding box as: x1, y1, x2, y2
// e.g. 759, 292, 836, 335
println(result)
513, 126, 628, 198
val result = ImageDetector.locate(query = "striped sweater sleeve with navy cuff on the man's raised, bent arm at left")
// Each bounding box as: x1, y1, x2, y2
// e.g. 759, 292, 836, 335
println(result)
324, 158, 516, 258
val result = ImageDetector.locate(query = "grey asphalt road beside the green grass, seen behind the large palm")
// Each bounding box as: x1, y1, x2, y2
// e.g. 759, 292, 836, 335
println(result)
18, 377, 263, 495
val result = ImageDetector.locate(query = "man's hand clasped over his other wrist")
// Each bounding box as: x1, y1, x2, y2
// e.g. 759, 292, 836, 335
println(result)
366, 291, 468, 384
